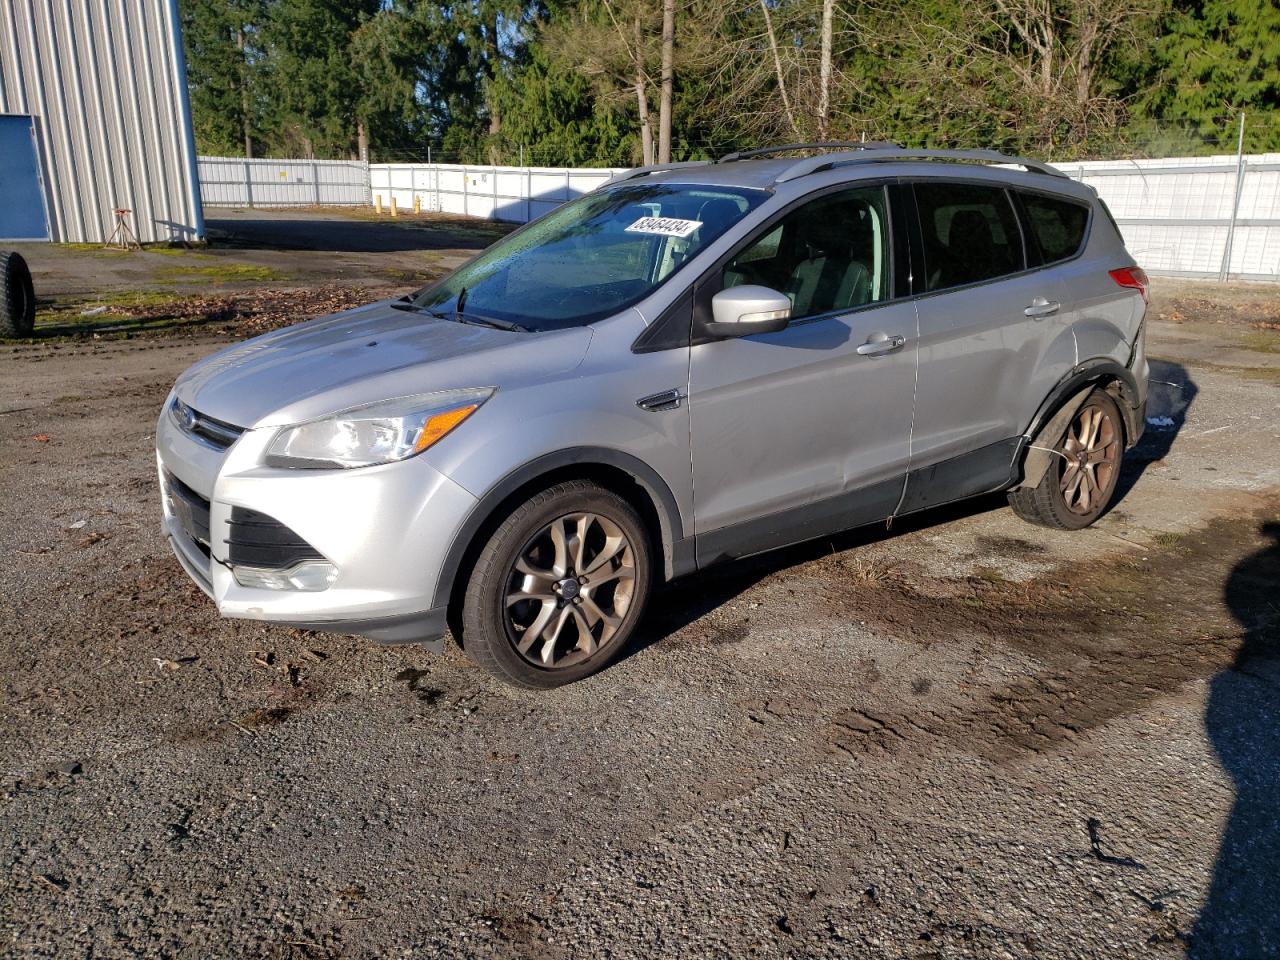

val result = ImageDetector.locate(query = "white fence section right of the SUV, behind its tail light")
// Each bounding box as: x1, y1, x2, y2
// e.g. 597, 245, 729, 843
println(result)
1057, 154, 1280, 280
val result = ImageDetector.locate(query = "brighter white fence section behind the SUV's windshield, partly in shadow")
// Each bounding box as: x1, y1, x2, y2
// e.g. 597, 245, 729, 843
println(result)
369, 164, 625, 223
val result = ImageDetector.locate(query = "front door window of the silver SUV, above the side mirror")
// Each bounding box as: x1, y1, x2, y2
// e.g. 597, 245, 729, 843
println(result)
723, 187, 890, 320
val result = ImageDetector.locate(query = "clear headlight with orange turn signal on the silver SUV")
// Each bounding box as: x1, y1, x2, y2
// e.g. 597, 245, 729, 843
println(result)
266, 387, 494, 468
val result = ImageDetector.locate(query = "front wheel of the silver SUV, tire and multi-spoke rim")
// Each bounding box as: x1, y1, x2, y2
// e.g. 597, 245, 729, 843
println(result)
461, 480, 653, 689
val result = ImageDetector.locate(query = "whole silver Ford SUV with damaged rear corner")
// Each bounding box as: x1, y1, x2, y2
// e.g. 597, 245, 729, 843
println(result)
156, 145, 1147, 687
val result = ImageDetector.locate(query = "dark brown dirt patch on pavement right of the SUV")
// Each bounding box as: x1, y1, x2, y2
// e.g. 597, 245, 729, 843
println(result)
819, 494, 1280, 762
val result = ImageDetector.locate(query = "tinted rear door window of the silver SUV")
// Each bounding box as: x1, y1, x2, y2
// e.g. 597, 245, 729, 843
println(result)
915, 180, 1025, 291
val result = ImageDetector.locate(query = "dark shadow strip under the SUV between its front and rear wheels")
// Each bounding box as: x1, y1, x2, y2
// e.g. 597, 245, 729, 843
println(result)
620, 493, 1009, 660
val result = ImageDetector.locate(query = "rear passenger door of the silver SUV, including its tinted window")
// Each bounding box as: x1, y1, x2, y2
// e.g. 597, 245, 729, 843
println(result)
904, 179, 1075, 511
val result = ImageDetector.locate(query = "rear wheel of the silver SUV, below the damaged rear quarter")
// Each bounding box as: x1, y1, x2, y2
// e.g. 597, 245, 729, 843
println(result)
1009, 389, 1125, 530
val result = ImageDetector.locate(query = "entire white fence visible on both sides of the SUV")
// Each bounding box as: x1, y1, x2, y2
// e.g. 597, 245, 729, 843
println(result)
192, 154, 1280, 280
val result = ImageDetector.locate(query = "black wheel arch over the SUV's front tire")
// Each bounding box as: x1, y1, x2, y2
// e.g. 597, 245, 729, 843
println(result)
433, 447, 695, 611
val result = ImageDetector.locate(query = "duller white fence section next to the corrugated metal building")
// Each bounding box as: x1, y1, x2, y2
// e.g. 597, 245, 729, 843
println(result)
200, 156, 370, 206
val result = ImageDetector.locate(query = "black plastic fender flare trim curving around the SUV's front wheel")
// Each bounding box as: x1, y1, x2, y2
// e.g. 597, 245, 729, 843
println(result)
433, 447, 695, 607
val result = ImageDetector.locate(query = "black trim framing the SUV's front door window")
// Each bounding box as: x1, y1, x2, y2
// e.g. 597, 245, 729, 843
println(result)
631, 177, 914, 353
